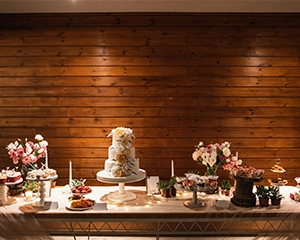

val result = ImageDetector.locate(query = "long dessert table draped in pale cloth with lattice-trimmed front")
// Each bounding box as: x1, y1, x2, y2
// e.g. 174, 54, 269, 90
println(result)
0, 186, 300, 239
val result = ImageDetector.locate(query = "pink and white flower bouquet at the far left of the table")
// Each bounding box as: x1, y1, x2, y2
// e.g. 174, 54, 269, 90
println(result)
6, 134, 48, 165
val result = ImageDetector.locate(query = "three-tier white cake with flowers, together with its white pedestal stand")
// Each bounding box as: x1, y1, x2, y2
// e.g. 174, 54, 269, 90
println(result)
96, 127, 146, 202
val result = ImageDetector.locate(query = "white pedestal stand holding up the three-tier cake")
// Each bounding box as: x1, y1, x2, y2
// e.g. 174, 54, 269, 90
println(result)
97, 169, 146, 203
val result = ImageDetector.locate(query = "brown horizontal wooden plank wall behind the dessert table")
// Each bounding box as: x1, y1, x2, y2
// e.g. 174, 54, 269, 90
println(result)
0, 13, 300, 185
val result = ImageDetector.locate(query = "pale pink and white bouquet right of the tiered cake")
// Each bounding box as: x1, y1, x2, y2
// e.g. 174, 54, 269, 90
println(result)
192, 142, 234, 176
